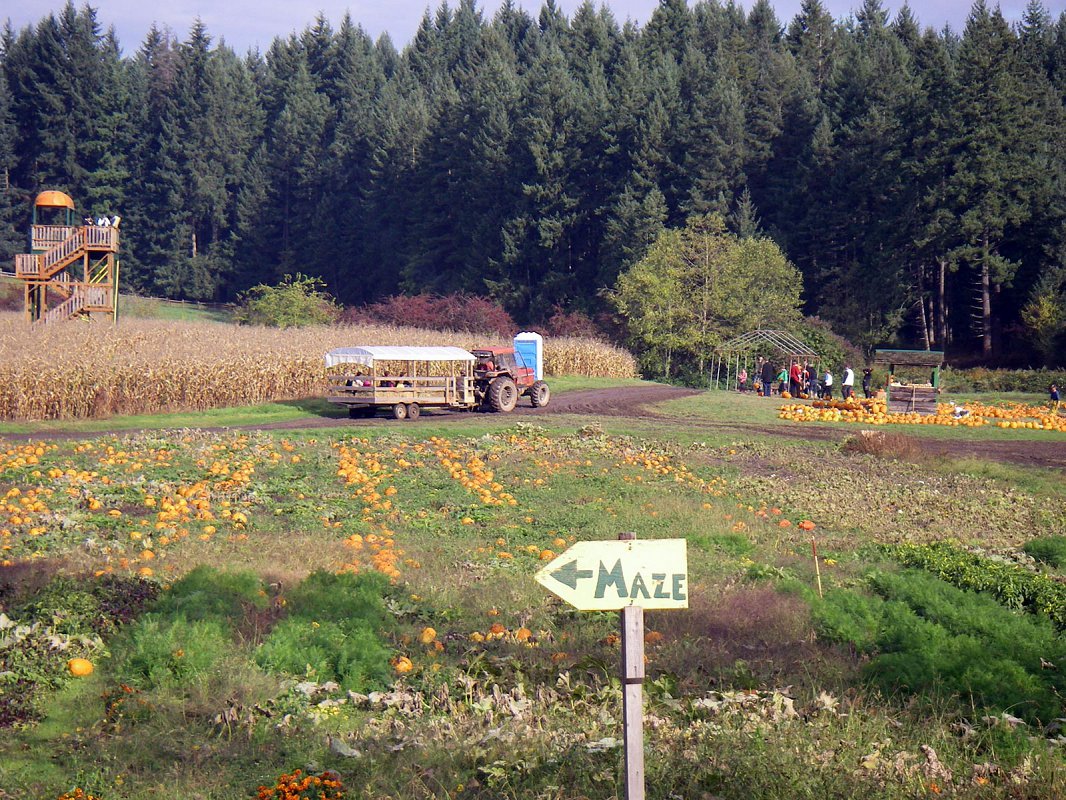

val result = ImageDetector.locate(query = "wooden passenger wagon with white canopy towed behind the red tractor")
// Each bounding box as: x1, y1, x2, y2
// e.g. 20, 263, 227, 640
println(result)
325, 346, 480, 419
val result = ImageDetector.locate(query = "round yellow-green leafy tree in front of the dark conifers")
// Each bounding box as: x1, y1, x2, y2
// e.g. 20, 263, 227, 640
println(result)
610, 214, 803, 378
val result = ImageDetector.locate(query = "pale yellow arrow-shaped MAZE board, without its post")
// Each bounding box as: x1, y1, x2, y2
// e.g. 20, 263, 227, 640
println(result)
536, 539, 689, 611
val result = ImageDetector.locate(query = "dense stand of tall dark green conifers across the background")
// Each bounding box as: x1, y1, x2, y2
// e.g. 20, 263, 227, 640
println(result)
0, 0, 1066, 357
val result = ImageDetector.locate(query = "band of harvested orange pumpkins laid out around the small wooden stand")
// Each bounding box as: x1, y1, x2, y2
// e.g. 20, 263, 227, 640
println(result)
777, 398, 1066, 432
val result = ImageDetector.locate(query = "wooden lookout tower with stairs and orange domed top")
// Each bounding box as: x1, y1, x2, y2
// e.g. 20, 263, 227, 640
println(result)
15, 191, 118, 324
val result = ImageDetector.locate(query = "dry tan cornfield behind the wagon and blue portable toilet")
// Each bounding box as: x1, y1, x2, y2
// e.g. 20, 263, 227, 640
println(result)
0, 313, 636, 419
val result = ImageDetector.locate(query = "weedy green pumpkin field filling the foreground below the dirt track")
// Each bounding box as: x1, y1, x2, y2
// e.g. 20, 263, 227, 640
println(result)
0, 386, 1066, 800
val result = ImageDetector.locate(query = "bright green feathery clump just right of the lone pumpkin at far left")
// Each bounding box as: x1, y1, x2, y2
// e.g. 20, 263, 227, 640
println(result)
112, 613, 233, 689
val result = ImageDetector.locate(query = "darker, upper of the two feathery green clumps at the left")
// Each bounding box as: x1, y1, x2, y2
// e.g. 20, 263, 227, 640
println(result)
152, 566, 269, 624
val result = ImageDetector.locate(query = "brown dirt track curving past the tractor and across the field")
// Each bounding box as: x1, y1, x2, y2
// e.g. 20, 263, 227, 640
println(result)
0, 386, 1066, 469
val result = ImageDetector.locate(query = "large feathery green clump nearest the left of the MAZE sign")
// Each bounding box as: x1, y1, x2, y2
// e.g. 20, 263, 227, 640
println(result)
256, 572, 390, 691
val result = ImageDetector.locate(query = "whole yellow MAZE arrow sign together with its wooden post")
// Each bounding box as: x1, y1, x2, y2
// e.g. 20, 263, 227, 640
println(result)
536, 533, 689, 800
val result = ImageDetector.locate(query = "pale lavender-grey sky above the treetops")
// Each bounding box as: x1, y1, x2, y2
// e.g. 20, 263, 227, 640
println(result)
0, 0, 1066, 54
